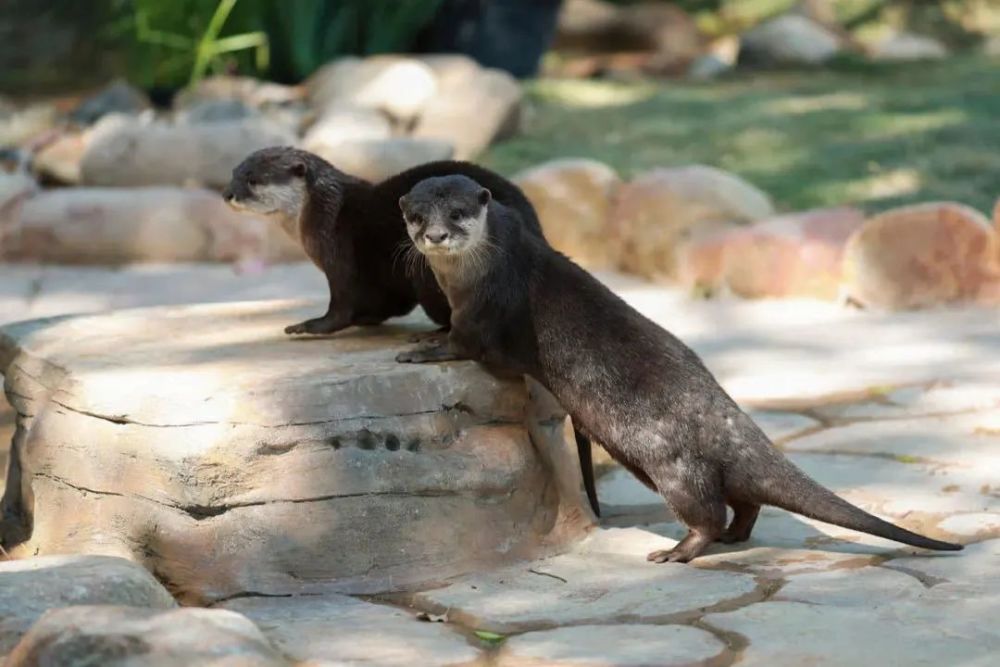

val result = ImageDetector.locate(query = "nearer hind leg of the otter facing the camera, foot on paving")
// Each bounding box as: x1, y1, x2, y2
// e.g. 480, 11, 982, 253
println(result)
646, 463, 726, 563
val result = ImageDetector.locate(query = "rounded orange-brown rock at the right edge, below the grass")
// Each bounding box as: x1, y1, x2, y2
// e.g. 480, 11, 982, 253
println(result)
844, 202, 1000, 310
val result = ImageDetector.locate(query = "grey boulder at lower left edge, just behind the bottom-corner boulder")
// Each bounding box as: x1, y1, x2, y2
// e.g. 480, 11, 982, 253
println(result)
0, 556, 177, 664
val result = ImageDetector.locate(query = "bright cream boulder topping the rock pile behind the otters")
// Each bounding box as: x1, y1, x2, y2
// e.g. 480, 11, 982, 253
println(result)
306, 56, 438, 124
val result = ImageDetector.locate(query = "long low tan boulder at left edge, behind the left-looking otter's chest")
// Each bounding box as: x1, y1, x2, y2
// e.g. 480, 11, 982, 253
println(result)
0, 187, 304, 264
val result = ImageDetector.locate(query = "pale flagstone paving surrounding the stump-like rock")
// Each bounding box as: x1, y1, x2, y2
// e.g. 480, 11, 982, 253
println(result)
0, 267, 1000, 667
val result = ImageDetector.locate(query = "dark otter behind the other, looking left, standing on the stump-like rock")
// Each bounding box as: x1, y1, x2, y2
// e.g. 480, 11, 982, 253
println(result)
223, 147, 600, 516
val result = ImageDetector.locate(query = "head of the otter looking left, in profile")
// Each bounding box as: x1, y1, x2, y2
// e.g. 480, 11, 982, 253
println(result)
222, 147, 309, 219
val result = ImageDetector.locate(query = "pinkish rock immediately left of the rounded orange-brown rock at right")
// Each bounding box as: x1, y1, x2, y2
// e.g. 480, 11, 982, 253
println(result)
678, 207, 865, 299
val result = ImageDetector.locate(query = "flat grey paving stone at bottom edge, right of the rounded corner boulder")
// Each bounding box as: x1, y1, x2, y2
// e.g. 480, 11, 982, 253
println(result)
224, 595, 481, 667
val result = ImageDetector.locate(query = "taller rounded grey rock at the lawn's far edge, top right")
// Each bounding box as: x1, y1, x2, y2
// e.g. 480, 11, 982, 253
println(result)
740, 14, 842, 66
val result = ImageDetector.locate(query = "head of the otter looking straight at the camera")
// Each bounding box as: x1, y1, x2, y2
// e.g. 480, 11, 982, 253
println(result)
399, 176, 491, 258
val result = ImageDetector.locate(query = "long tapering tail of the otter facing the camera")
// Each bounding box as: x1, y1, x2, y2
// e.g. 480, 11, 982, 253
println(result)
754, 452, 962, 551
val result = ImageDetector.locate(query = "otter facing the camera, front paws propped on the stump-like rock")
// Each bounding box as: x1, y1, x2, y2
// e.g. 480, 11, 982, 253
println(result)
397, 176, 962, 563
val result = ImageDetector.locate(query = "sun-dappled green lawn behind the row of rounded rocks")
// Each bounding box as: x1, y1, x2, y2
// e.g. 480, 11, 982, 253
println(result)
484, 57, 1000, 211
